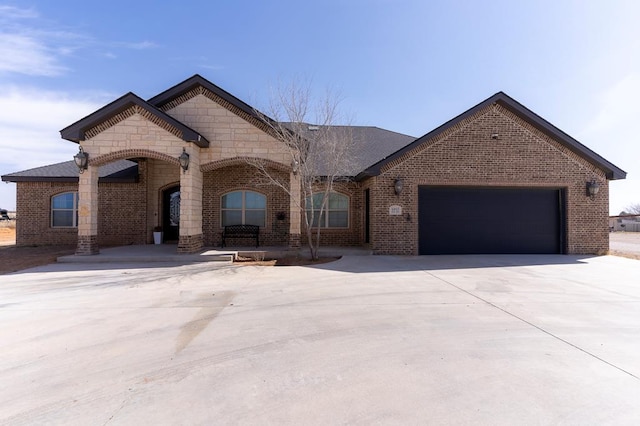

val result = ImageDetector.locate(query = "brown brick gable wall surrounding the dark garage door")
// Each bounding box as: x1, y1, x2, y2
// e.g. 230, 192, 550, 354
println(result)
367, 105, 609, 255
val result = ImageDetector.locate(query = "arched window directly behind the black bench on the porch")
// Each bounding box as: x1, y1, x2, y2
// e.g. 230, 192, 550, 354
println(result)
220, 191, 267, 226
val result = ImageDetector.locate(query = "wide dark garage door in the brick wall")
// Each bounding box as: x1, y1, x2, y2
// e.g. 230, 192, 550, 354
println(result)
418, 186, 565, 254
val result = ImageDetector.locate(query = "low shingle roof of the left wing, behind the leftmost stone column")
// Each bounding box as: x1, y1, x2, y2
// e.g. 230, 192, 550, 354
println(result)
2, 160, 138, 183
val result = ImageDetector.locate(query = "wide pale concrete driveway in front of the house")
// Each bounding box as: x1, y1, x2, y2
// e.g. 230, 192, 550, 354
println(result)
0, 256, 640, 425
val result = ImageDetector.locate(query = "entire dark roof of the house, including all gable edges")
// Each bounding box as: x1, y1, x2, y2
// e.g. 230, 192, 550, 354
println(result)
2, 74, 626, 182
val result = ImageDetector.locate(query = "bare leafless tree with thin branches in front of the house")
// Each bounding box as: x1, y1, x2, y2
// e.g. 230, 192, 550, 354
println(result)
247, 82, 356, 260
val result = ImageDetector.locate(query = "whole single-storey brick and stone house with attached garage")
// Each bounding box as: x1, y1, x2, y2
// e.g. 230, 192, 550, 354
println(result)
2, 75, 626, 255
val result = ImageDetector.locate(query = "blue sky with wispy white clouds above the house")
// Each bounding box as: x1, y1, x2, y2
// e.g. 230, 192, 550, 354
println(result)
0, 0, 640, 214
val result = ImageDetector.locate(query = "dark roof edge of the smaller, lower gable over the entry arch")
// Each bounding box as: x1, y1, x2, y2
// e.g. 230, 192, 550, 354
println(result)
60, 92, 209, 148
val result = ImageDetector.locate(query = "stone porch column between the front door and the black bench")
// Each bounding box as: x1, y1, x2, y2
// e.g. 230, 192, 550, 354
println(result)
178, 144, 204, 253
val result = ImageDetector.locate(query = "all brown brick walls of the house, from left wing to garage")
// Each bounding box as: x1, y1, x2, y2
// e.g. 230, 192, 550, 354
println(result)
17, 105, 609, 255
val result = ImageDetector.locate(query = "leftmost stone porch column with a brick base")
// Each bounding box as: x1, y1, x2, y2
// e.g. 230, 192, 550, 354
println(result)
76, 166, 100, 256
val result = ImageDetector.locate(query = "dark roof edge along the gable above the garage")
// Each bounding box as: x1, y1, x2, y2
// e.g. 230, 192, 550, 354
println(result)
356, 92, 627, 180
